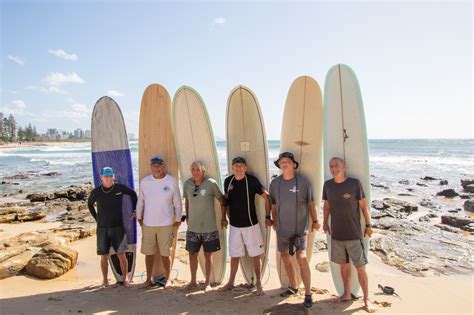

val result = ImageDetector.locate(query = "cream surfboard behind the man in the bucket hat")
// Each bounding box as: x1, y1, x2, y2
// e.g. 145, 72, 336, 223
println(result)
277, 76, 323, 287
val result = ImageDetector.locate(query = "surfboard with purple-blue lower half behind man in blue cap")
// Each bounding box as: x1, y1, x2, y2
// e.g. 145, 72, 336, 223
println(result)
91, 96, 137, 282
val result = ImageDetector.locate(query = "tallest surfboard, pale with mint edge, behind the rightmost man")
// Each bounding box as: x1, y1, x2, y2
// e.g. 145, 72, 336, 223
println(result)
324, 64, 371, 296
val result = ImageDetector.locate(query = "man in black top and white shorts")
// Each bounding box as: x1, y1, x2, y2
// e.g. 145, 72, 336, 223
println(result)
221, 157, 270, 296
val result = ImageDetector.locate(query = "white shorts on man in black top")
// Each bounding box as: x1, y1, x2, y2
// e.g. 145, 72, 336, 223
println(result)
229, 223, 265, 257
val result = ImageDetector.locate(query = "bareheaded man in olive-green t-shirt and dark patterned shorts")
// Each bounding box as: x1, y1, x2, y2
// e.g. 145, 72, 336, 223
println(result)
183, 161, 225, 292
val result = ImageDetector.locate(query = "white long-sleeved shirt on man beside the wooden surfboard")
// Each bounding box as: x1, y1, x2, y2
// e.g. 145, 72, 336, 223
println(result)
137, 174, 183, 226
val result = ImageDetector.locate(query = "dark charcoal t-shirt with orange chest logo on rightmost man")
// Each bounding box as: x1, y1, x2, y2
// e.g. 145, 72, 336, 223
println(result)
323, 177, 365, 241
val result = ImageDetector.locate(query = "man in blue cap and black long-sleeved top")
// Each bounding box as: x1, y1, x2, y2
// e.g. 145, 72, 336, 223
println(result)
87, 167, 137, 288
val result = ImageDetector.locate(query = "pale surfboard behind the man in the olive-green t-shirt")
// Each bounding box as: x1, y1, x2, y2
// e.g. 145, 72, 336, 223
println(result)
173, 86, 227, 284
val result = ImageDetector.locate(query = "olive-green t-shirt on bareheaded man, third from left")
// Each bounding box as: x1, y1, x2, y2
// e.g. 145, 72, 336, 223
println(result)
183, 177, 222, 233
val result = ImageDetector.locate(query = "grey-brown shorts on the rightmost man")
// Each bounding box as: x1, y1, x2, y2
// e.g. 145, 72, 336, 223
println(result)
331, 238, 368, 267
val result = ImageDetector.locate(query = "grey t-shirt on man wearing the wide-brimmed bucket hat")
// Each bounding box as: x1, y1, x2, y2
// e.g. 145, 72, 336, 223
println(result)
270, 174, 314, 238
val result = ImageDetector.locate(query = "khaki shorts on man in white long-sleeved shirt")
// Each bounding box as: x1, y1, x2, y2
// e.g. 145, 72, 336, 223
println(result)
141, 225, 174, 257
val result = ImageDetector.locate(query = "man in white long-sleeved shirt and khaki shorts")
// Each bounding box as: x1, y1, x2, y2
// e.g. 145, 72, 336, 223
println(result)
137, 155, 183, 288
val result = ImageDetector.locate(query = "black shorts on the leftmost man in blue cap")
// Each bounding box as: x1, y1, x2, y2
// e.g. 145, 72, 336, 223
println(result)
97, 226, 128, 256
